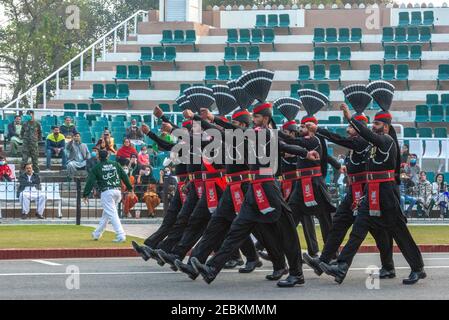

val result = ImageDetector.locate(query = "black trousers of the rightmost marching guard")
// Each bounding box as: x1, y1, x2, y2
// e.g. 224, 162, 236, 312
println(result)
338, 210, 424, 271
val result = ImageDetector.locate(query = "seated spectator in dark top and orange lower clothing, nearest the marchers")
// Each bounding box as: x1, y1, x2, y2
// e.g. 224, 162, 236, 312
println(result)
136, 166, 161, 218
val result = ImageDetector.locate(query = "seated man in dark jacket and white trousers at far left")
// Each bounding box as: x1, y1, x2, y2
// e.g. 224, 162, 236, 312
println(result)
17, 163, 46, 219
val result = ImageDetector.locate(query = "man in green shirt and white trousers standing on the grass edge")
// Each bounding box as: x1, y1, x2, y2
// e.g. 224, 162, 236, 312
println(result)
83, 150, 134, 242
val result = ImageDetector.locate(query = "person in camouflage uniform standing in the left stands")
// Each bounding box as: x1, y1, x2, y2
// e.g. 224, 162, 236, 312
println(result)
20, 110, 42, 173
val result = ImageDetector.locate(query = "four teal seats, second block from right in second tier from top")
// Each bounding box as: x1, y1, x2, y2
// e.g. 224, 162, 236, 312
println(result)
313, 28, 362, 46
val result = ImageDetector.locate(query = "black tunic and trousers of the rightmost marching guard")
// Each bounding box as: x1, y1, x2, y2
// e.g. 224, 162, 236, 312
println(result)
338, 119, 424, 272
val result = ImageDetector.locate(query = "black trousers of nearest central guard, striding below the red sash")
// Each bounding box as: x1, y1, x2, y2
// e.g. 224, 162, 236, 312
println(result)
207, 211, 302, 275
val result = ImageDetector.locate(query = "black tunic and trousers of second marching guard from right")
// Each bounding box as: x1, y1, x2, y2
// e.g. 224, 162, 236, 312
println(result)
317, 128, 394, 270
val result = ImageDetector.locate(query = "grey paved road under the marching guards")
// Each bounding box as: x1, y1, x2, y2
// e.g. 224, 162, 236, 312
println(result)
0, 254, 449, 300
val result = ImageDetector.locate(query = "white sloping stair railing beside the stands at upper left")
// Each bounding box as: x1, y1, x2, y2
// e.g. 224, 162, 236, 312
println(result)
3, 10, 148, 109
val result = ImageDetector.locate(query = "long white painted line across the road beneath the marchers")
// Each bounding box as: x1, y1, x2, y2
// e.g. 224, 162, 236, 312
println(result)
0, 266, 449, 277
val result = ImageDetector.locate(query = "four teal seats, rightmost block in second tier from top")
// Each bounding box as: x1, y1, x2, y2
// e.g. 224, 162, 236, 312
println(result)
382, 27, 432, 50
